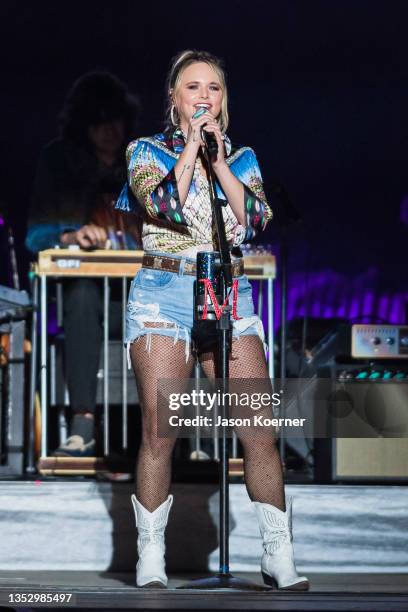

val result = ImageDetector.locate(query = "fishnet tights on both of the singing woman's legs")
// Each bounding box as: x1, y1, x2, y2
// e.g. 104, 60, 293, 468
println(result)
130, 335, 285, 512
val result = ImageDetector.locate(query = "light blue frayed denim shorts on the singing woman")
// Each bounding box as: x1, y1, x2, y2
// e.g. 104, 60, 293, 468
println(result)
126, 252, 265, 359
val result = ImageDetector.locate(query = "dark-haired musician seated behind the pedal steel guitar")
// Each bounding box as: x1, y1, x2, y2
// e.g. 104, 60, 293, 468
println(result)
26, 72, 140, 457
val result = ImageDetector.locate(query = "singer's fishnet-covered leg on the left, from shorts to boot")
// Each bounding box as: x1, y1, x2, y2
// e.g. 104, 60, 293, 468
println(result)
130, 334, 193, 512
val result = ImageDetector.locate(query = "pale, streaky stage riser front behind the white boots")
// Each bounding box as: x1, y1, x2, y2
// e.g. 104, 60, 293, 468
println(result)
0, 481, 408, 573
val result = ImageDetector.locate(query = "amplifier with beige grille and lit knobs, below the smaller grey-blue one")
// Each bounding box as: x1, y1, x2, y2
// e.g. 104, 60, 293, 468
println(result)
314, 360, 408, 482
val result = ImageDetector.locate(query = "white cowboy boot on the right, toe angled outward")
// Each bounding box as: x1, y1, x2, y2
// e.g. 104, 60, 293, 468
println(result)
252, 497, 309, 591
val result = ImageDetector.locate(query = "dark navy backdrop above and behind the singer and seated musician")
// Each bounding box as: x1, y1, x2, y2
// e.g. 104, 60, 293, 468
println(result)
0, 0, 408, 306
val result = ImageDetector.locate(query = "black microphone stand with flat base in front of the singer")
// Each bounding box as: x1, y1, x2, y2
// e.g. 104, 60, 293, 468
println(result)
179, 141, 269, 591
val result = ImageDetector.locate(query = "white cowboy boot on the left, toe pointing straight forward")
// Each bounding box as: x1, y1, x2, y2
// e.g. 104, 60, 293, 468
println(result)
132, 495, 173, 588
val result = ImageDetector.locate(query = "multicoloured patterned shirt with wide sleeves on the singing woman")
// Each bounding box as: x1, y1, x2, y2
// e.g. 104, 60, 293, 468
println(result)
116, 129, 272, 253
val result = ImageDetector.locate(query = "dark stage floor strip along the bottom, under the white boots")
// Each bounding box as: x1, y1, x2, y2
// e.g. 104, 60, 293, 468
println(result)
0, 571, 408, 612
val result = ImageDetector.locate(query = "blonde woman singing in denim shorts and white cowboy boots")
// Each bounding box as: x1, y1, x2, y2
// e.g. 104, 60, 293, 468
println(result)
116, 51, 309, 590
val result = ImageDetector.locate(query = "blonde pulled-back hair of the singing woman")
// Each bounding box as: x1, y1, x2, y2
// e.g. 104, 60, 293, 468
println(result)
166, 49, 229, 133
